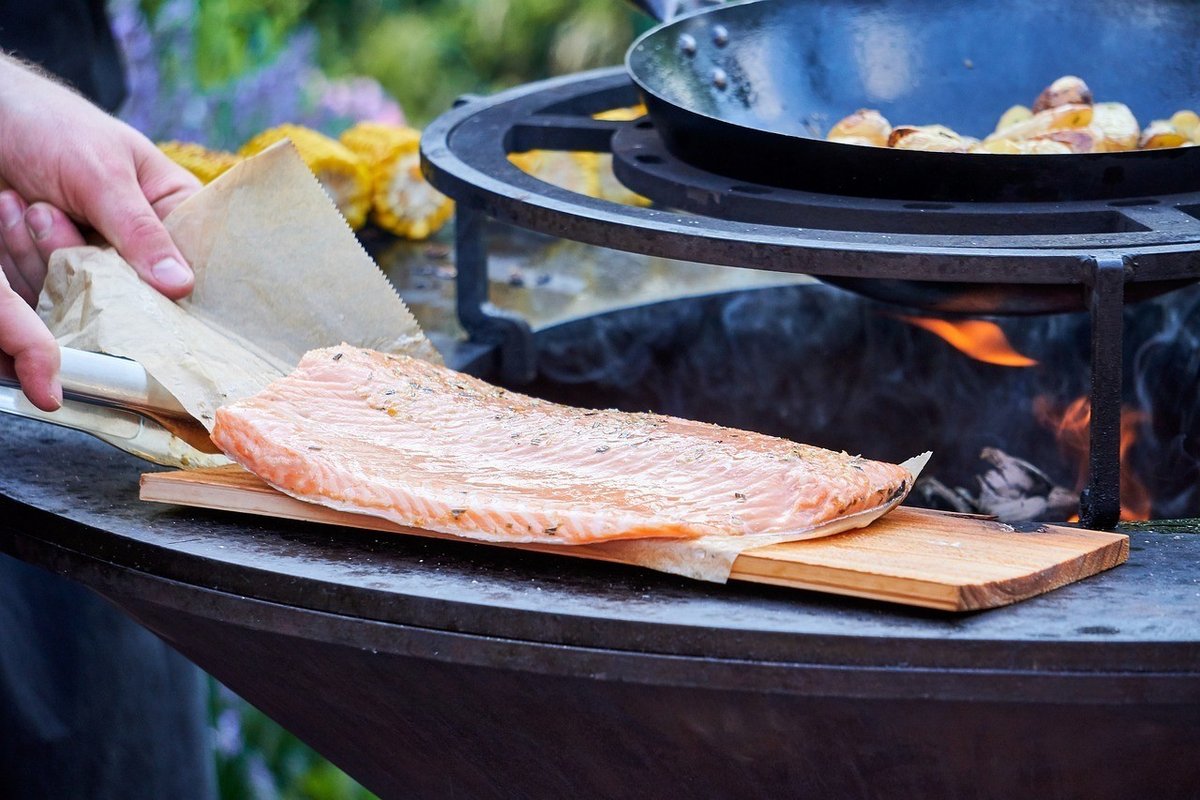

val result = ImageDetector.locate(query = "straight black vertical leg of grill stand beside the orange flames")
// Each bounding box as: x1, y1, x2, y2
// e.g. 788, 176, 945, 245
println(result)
1079, 258, 1128, 529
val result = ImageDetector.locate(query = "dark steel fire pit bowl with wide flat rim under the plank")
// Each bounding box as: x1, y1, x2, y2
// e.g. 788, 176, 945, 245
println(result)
0, 335, 1200, 798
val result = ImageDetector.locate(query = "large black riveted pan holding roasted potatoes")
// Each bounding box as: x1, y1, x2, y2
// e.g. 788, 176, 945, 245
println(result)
626, 0, 1200, 201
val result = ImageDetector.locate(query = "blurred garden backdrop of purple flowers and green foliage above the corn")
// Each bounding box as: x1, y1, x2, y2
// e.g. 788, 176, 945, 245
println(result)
109, 0, 649, 150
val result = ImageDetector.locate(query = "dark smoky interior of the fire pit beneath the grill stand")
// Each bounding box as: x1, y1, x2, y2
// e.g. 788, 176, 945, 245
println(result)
523, 284, 1200, 517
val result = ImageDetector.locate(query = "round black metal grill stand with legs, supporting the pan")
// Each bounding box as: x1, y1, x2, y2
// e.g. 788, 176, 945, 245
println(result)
422, 70, 1200, 528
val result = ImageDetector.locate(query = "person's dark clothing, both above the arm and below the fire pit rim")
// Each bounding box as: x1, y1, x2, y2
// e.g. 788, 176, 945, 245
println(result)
0, 6, 216, 800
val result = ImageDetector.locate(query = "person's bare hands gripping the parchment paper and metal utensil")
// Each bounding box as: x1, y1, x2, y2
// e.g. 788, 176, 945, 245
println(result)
0, 55, 199, 410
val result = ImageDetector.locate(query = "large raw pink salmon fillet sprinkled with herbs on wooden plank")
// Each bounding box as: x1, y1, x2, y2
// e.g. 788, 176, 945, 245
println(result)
212, 344, 912, 545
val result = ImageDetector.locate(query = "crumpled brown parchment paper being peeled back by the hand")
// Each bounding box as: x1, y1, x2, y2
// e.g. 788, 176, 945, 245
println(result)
38, 142, 440, 429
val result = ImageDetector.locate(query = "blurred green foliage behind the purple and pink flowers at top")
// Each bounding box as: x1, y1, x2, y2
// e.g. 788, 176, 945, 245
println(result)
140, 0, 650, 125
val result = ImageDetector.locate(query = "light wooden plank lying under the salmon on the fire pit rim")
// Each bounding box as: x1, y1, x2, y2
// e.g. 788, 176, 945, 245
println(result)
142, 467, 1129, 610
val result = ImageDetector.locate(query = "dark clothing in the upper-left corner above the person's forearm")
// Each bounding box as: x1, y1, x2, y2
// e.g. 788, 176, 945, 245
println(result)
0, 0, 125, 112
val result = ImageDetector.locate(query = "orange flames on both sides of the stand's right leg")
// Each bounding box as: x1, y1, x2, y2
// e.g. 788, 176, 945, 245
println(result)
1033, 396, 1151, 521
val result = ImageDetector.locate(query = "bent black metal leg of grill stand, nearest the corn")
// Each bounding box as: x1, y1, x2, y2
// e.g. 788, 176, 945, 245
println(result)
455, 204, 538, 384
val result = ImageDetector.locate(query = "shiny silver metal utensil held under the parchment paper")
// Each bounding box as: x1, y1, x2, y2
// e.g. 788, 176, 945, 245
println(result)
0, 348, 230, 469
